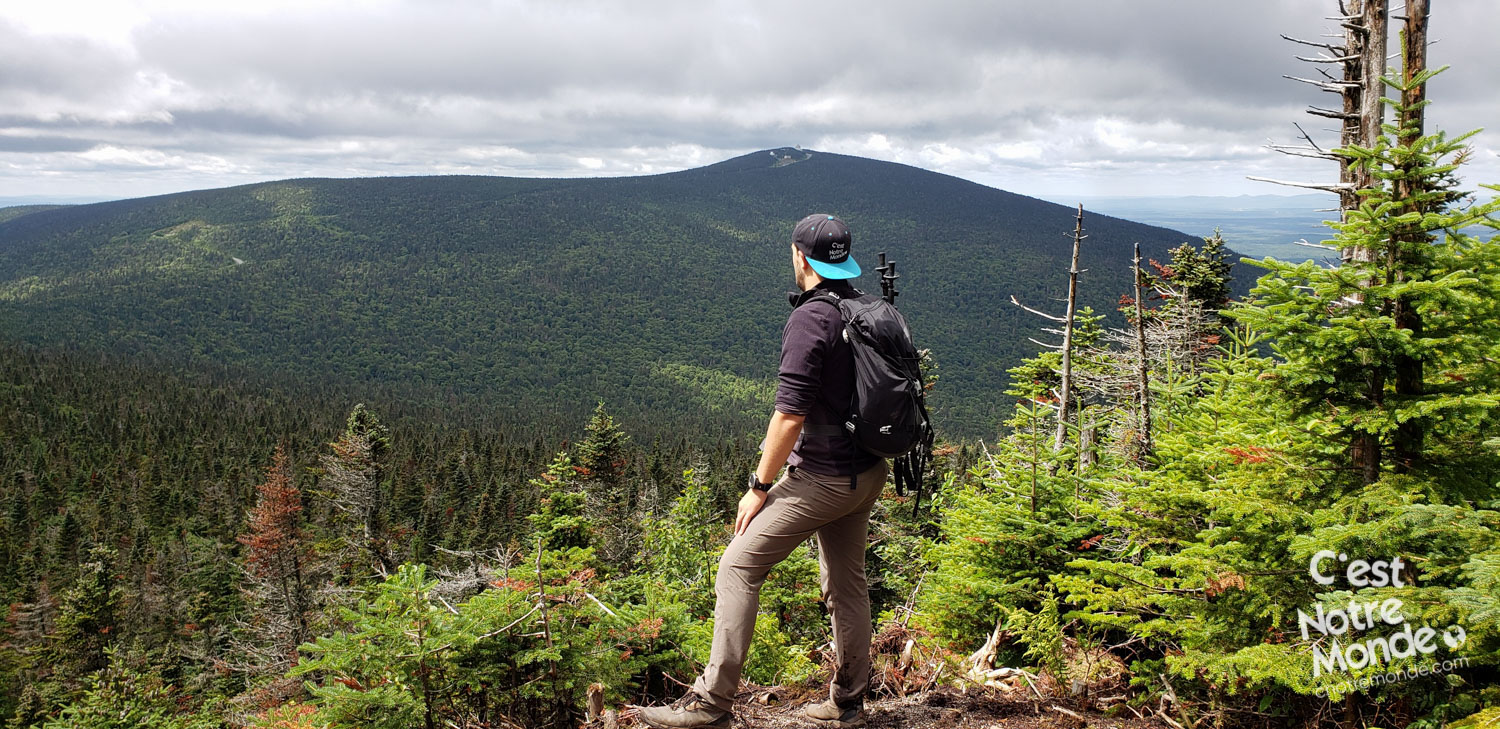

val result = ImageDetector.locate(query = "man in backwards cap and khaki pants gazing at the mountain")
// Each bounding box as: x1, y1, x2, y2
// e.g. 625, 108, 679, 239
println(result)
641, 215, 890, 728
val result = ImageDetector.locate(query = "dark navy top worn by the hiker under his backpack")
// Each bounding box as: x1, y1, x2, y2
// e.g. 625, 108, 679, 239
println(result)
776, 281, 881, 476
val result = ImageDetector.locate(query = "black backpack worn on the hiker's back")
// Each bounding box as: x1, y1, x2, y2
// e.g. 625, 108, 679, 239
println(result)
803, 290, 933, 510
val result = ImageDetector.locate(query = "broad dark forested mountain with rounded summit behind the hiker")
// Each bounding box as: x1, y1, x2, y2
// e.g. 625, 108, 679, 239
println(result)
0, 149, 1218, 438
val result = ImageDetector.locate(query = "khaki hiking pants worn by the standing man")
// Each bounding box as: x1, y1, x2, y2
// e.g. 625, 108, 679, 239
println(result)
693, 459, 890, 710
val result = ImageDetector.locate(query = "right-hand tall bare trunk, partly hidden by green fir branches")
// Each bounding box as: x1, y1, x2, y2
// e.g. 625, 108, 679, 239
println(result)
1388, 0, 1431, 471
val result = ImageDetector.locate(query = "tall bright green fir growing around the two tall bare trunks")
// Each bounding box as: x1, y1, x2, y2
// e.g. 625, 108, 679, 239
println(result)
1230, 69, 1500, 485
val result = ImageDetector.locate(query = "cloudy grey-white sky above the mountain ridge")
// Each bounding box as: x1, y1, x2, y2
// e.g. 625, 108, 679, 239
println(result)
0, 0, 1500, 198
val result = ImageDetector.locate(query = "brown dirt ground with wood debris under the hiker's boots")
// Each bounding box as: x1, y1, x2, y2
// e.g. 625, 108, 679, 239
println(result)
618, 689, 1169, 729
